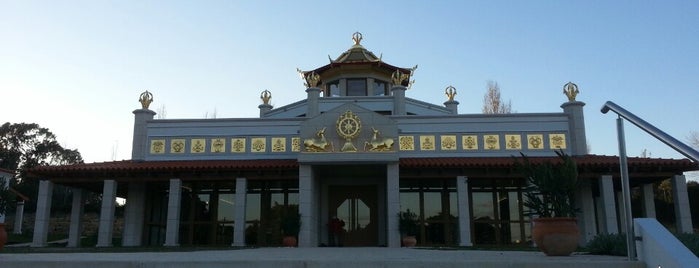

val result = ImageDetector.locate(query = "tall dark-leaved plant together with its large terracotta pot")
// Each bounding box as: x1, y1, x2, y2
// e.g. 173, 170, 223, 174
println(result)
516, 150, 580, 256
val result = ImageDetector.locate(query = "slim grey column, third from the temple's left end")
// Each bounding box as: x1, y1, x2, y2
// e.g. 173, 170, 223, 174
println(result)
96, 180, 117, 247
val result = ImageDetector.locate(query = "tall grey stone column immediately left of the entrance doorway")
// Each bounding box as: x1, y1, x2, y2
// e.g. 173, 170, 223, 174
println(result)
298, 165, 318, 247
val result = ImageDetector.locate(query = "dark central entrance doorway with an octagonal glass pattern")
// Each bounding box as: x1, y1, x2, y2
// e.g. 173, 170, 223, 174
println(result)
328, 185, 379, 247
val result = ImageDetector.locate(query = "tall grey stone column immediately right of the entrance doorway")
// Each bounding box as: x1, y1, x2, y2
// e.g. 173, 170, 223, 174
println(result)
386, 163, 401, 248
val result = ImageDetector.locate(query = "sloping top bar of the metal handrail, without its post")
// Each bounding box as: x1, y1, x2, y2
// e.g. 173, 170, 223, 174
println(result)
601, 101, 699, 162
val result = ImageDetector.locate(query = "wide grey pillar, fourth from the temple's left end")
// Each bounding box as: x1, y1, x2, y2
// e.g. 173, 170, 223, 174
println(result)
121, 182, 146, 247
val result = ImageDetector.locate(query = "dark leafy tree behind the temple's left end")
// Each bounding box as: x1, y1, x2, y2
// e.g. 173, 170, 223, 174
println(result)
0, 122, 83, 214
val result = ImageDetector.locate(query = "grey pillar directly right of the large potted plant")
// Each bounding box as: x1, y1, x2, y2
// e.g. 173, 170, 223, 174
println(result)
575, 179, 597, 246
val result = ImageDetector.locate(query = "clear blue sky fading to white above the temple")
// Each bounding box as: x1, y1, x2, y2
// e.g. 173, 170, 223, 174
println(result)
0, 0, 699, 180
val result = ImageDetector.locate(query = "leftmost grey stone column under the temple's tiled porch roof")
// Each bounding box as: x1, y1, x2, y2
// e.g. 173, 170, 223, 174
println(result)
32, 180, 53, 247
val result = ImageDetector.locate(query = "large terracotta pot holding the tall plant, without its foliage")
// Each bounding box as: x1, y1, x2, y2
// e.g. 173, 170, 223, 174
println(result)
532, 218, 580, 256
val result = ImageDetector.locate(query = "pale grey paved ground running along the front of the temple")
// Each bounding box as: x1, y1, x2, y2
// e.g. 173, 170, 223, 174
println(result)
0, 248, 644, 268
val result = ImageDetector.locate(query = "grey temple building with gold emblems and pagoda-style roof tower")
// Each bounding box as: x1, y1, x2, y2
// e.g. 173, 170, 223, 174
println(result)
30, 33, 698, 247
